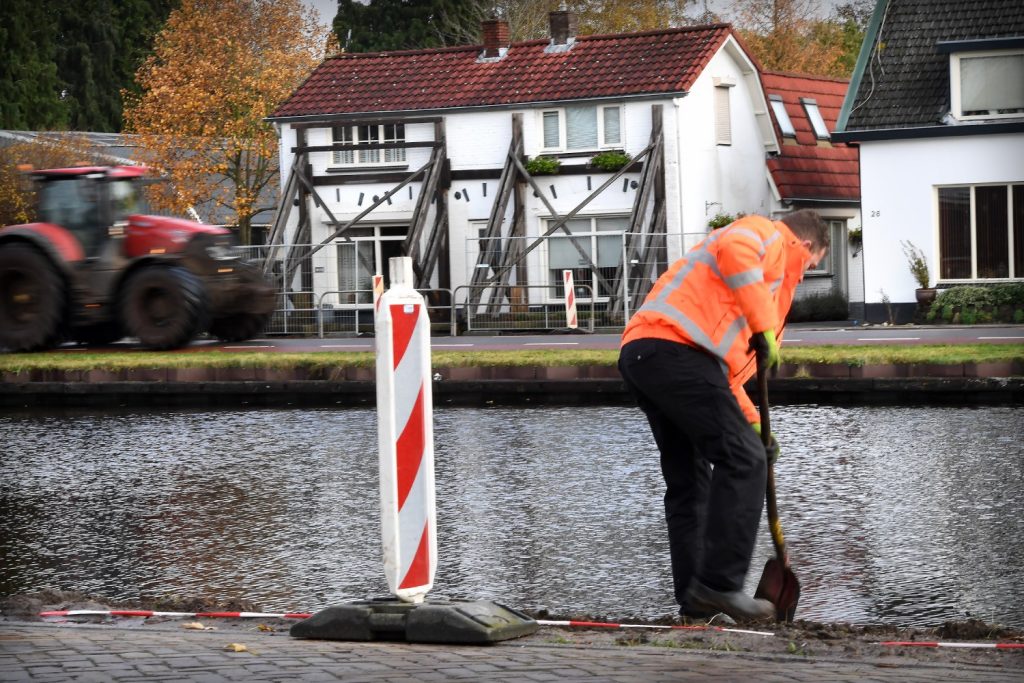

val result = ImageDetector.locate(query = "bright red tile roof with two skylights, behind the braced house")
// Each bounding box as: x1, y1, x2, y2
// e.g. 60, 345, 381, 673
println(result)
761, 72, 860, 201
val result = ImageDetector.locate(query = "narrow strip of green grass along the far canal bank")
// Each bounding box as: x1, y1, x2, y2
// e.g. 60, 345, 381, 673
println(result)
0, 344, 1024, 374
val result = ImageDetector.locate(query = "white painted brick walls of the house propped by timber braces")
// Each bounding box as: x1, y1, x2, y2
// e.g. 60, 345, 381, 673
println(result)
280, 39, 790, 301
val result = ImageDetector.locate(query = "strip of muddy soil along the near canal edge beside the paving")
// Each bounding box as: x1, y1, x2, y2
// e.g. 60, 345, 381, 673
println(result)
0, 590, 1024, 677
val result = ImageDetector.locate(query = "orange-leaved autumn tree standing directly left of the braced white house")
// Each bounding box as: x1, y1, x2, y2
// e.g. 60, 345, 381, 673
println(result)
125, 0, 326, 244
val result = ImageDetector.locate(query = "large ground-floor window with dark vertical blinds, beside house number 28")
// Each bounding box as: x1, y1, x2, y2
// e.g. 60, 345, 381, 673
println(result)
938, 184, 1024, 280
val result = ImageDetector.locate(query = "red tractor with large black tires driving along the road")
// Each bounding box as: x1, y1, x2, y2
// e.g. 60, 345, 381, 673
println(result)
0, 166, 274, 351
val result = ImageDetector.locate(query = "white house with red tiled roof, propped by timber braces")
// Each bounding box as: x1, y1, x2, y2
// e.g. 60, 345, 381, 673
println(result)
270, 11, 850, 325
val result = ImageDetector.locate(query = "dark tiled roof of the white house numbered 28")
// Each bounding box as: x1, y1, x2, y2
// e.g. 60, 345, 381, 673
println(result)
841, 0, 1024, 131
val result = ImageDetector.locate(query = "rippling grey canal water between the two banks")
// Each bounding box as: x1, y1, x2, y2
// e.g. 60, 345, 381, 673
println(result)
0, 405, 1024, 628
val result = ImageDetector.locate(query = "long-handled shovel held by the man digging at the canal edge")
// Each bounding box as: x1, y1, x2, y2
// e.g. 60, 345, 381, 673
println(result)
754, 351, 800, 622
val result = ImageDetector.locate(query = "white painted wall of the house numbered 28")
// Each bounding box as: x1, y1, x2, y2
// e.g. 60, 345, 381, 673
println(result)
860, 134, 1024, 303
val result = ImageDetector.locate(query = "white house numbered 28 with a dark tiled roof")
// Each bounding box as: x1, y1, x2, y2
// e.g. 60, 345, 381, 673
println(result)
833, 0, 1024, 322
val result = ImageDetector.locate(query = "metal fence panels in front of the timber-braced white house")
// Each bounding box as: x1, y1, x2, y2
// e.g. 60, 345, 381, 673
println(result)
245, 231, 705, 337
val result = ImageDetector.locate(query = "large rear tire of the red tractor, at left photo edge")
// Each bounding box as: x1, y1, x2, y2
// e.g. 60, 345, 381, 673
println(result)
0, 244, 68, 351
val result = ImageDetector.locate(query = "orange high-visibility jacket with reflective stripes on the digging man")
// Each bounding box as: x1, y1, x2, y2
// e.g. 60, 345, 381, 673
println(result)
622, 216, 811, 423
